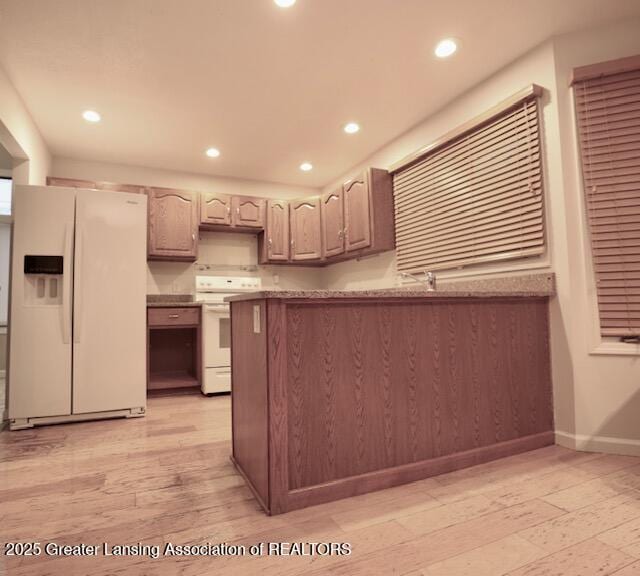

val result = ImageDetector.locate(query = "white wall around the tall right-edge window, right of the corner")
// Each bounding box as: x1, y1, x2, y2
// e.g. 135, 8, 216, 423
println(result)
554, 20, 640, 454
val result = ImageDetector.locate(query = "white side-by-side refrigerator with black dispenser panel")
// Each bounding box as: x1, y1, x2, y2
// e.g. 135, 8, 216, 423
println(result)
8, 186, 147, 429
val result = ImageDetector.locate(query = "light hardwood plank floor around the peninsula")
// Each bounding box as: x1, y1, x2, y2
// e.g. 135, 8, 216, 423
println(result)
0, 396, 640, 576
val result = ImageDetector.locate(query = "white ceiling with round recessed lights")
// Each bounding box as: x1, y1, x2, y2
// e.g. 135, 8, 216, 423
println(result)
0, 0, 640, 186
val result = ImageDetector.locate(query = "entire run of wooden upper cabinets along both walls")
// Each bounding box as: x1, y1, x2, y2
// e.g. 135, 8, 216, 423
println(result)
47, 168, 395, 264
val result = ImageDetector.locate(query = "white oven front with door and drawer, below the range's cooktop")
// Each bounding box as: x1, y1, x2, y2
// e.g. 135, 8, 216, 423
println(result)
202, 304, 231, 394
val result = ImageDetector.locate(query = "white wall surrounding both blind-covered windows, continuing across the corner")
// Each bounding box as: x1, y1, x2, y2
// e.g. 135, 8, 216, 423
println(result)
325, 21, 640, 454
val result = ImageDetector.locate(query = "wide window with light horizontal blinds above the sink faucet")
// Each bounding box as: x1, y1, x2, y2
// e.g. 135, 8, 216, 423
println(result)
391, 86, 544, 273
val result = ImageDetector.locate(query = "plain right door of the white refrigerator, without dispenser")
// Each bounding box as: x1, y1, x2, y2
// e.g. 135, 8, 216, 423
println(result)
73, 190, 147, 414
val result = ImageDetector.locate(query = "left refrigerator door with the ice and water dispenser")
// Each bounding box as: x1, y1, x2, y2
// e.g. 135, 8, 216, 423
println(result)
8, 186, 75, 420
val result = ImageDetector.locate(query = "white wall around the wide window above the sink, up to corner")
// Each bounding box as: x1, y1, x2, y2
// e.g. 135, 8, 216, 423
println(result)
325, 41, 574, 430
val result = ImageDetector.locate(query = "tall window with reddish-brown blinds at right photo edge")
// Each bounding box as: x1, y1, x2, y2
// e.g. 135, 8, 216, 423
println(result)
573, 57, 640, 338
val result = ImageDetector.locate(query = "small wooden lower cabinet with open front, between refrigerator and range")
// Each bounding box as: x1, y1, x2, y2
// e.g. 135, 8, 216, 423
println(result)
147, 306, 202, 390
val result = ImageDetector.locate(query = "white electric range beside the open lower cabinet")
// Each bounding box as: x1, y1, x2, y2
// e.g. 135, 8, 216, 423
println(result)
195, 276, 262, 395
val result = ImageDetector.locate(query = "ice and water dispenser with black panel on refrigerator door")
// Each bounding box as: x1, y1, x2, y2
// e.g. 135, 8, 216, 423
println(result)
24, 255, 64, 306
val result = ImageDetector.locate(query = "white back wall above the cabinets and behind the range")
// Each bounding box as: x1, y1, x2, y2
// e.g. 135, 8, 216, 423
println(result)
50, 158, 323, 294
